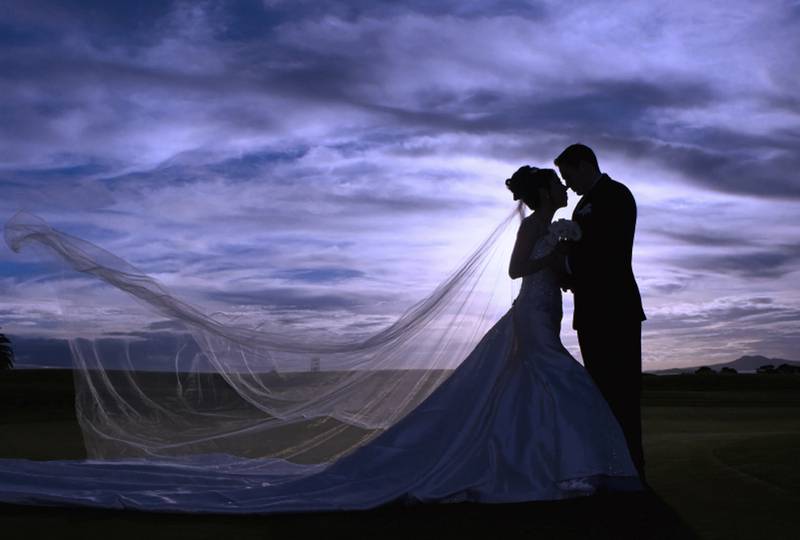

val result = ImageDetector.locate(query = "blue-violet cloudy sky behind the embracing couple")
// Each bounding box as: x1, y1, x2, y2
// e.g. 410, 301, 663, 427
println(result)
0, 0, 800, 369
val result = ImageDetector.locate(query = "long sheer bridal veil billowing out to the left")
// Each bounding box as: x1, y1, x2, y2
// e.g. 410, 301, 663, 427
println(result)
5, 207, 521, 464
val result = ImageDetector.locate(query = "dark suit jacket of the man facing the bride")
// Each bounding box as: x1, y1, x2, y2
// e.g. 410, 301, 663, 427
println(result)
567, 174, 646, 330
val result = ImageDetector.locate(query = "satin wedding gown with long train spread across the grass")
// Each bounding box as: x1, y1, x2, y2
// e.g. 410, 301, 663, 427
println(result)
0, 227, 641, 513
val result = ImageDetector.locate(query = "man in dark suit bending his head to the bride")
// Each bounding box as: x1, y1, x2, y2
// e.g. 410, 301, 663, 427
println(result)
554, 144, 645, 480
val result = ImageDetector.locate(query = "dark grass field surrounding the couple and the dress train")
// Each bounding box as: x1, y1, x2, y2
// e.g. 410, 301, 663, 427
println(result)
0, 371, 800, 540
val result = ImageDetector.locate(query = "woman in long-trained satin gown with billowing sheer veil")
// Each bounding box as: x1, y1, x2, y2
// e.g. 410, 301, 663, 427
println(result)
0, 167, 641, 513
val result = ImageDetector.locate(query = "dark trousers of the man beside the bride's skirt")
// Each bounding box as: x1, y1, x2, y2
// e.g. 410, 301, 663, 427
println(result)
578, 321, 645, 480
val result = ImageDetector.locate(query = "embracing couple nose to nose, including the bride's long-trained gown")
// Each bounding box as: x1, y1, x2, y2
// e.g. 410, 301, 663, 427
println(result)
0, 144, 645, 513
